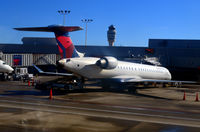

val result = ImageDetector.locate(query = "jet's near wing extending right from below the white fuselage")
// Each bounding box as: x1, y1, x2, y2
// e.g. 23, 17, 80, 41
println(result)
112, 76, 197, 83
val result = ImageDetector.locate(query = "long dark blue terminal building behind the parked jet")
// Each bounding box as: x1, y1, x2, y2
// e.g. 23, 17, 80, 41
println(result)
0, 37, 200, 80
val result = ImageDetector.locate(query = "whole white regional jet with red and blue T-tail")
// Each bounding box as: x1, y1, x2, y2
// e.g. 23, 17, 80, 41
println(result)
15, 25, 192, 91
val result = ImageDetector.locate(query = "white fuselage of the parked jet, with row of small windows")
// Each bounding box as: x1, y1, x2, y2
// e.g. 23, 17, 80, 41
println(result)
59, 57, 171, 80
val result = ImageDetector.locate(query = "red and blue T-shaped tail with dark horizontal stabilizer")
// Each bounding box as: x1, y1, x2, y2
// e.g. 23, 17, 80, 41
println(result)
14, 25, 83, 58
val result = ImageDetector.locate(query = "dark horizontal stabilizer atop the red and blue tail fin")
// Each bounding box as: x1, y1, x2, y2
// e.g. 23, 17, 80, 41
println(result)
14, 25, 83, 32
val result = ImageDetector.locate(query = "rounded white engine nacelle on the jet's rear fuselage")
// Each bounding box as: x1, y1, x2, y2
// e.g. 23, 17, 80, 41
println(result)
96, 57, 118, 69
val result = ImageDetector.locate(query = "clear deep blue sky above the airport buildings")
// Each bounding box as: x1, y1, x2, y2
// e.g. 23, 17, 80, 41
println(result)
0, 0, 200, 47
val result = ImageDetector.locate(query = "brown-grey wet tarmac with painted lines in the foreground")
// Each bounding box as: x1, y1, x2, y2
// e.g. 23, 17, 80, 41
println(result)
0, 78, 200, 132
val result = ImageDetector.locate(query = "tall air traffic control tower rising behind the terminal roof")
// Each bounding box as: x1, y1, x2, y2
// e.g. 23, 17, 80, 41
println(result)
107, 25, 116, 46
